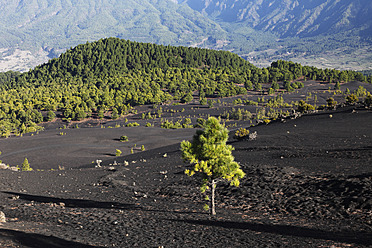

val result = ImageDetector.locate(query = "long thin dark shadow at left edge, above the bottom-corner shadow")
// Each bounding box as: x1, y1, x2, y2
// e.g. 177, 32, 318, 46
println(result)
2, 191, 140, 210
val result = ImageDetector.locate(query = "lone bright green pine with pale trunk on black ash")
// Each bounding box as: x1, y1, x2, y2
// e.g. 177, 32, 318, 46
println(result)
181, 117, 245, 215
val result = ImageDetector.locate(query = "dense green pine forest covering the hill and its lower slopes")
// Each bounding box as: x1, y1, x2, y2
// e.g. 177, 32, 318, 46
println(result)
0, 38, 372, 137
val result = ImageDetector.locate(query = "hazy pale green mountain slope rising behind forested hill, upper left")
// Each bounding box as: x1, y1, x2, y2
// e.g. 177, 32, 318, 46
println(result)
0, 0, 226, 71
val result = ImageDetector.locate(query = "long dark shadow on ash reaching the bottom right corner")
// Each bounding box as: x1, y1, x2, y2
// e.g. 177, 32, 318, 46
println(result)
167, 219, 372, 246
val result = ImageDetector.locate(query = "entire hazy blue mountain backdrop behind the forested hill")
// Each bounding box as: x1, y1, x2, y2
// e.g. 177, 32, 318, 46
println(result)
0, 0, 372, 71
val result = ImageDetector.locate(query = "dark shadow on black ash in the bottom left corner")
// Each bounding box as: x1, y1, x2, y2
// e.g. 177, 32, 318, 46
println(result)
0, 228, 100, 248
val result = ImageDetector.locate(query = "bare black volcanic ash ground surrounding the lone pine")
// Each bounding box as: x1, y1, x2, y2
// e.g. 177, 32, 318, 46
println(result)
0, 81, 372, 247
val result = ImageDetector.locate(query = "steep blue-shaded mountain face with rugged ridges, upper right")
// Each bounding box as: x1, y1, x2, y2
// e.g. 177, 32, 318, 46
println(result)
186, 0, 372, 37
